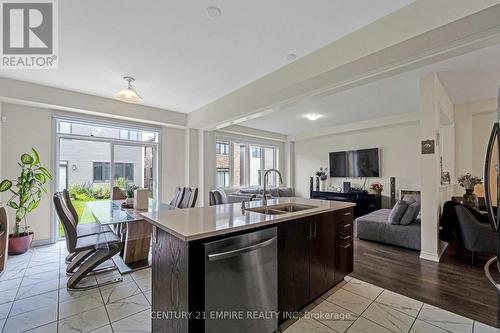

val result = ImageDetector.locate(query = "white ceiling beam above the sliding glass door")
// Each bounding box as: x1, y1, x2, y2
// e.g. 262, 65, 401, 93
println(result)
0, 78, 187, 128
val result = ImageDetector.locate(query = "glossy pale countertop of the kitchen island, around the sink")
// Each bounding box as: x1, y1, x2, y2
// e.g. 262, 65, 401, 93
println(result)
141, 197, 355, 242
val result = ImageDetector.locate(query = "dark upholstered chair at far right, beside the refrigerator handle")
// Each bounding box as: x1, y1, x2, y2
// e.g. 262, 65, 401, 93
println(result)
455, 205, 497, 266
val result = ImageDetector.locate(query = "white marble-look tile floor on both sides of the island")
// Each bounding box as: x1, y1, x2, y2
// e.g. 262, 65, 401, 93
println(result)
0, 243, 500, 333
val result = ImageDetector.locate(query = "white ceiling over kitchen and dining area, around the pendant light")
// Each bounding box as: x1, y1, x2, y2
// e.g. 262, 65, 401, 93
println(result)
0, 0, 413, 112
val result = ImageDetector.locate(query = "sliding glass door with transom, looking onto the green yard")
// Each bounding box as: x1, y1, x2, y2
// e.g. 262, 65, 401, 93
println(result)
54, 121, 158, 237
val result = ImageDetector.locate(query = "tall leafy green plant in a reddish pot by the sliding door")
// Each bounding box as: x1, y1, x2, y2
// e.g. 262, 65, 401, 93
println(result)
0, 148, 53, 254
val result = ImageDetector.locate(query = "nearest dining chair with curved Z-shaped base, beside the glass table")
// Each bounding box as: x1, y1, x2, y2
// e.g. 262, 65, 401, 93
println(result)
53, 193, 122, 290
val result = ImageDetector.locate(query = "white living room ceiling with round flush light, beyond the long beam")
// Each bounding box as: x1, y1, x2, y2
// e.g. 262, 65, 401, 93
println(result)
239, 45, 500, 135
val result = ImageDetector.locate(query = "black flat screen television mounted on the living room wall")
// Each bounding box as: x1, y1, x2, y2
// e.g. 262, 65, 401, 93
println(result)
330, 148, 380, 177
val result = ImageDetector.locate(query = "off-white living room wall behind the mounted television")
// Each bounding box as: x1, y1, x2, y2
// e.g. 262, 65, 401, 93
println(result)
293, 122, 420, 207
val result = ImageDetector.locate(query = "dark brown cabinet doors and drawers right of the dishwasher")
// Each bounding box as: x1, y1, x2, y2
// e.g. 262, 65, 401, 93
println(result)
278, 208, 353, 319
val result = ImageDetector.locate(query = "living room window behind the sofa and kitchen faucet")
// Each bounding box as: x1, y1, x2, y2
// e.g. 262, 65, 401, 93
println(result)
215, 140, 279, 187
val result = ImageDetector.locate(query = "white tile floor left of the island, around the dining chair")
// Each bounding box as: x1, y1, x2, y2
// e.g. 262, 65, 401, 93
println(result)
0, 243, 151, 333
